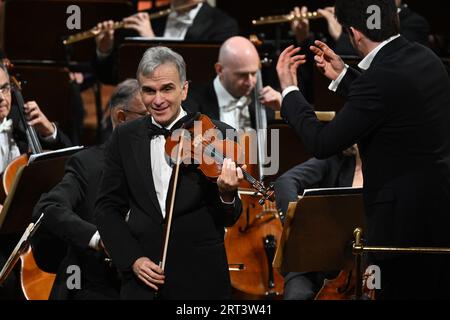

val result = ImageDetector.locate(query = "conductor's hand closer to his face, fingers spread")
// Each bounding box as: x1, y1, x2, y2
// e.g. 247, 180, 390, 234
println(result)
310, 40, 345, 80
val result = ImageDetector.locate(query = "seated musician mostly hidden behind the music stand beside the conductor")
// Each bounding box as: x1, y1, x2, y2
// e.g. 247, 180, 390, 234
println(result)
275, 145, 363, 300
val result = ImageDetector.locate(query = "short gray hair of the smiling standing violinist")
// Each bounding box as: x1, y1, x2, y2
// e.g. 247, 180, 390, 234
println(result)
137, 47, 186, 84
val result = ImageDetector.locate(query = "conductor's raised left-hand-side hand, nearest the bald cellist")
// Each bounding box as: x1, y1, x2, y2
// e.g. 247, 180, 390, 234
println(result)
277, 46, 306, 90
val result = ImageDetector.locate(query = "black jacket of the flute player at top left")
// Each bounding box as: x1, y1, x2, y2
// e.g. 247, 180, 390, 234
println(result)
94, 2, 239, 84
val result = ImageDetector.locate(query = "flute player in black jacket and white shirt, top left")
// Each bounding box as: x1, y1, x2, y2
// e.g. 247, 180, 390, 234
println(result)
95, 0, 239, 84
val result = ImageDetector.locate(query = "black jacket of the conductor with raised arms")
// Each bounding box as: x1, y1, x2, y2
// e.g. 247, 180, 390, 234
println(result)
281, 37, 450, 251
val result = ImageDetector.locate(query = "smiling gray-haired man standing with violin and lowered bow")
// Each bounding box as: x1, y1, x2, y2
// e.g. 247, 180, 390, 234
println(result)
96, 47, 242, 300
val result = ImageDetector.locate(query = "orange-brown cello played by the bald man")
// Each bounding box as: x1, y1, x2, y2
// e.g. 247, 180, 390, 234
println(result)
225, 66, 284, 299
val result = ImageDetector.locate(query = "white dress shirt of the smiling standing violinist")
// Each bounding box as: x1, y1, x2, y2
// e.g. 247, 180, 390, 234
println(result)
150, 106, 187, 217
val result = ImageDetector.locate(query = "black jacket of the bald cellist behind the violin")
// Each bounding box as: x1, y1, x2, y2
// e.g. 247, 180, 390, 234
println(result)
187, 81, 275, 128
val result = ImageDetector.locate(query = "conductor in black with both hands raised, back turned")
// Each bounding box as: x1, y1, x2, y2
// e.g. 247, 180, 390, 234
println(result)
277, 0, 450, 299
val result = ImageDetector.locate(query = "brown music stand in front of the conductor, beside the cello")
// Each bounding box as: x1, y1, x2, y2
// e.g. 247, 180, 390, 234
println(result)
274, 188, 365, 273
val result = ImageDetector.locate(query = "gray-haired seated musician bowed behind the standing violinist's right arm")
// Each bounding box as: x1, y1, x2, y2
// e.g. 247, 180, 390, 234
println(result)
33, 79, 147, 300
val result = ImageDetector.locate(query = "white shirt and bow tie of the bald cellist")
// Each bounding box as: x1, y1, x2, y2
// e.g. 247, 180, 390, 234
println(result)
214, 76, 251, 130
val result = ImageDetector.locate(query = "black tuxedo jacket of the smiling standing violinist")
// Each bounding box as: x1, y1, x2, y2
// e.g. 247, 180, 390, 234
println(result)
96, 117, 241, 299
